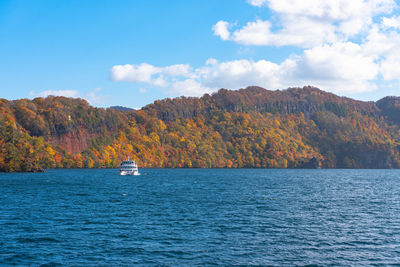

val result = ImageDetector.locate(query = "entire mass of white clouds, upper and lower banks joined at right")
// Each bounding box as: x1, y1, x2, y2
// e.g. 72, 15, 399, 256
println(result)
111, 0, 400, 96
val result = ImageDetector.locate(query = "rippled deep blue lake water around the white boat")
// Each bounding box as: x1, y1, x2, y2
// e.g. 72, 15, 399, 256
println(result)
0, 169, 400, 266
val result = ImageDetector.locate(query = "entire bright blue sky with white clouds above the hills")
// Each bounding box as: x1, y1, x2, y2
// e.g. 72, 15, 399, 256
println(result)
0, 0, 400, 107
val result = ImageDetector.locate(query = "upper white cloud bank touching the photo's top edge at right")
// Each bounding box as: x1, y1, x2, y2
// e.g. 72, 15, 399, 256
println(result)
213, 0, 396, 48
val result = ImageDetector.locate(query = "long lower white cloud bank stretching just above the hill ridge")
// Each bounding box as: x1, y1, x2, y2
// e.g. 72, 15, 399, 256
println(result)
112, 42, 382, 96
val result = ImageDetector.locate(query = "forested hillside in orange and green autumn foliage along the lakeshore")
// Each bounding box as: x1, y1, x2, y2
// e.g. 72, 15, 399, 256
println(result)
0, 87, 400, 172
